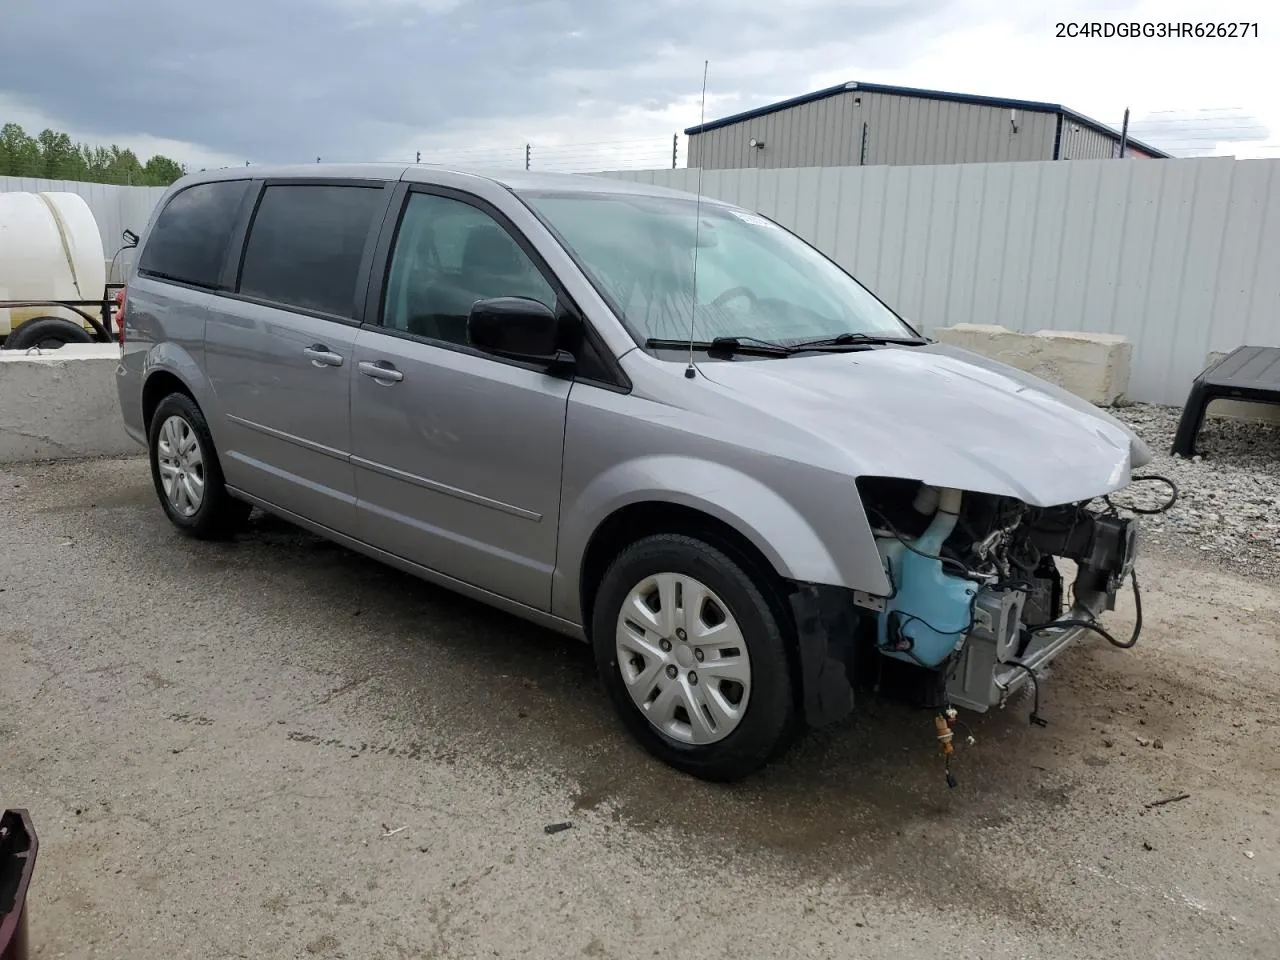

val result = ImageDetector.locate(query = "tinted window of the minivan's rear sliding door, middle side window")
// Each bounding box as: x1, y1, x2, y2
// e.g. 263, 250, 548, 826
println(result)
239, 184, 384, 319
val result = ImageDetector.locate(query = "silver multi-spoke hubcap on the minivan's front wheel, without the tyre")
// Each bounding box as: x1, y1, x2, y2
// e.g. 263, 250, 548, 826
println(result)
617, 573, 751, 745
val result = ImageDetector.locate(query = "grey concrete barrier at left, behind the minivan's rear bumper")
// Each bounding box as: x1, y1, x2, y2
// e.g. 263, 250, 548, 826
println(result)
0, 343, 141, 463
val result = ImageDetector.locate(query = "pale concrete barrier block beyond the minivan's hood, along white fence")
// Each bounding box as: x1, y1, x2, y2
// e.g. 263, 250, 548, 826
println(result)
933, 324, 1133, 407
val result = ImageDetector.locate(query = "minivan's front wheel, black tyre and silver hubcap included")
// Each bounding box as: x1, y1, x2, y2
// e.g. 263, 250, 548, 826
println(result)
591, 534, 795, 781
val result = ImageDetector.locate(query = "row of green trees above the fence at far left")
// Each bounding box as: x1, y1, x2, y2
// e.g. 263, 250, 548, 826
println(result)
0, 123, 183, 187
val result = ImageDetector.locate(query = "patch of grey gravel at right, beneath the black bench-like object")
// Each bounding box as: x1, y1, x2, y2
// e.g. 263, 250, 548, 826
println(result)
1111, 404, 1280, 580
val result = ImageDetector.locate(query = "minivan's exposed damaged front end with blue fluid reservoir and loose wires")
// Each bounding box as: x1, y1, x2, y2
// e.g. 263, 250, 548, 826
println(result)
792, 477, 1140, 748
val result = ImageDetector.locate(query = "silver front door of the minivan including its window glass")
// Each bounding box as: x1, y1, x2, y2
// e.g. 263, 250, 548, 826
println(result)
352, 191, 571, 611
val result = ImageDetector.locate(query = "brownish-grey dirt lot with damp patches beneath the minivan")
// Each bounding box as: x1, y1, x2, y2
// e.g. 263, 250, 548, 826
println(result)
0, 460, 1280, 960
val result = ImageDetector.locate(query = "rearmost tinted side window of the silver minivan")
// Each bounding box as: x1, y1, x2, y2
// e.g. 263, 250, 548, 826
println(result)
138, 180, 250, 287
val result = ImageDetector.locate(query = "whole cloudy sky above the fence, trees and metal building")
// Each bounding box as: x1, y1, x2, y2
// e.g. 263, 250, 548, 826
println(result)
0, 0, 1280, 169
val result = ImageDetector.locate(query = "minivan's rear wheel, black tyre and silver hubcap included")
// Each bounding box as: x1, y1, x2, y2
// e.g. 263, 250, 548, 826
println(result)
147, 393, 252, 540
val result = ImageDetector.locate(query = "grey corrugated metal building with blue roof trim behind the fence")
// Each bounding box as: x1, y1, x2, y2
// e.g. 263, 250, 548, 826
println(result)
685, 83, 1169, 170
